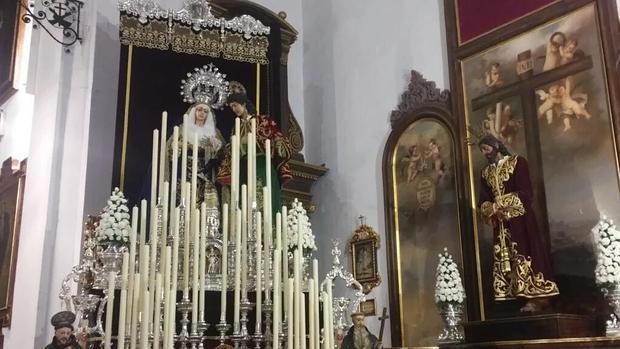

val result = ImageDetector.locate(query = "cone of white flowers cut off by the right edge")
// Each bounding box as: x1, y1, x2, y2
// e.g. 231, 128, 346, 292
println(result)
592, 216, 620, 289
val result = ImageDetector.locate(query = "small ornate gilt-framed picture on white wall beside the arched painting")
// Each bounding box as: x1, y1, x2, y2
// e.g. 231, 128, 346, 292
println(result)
349, 222, 381, 293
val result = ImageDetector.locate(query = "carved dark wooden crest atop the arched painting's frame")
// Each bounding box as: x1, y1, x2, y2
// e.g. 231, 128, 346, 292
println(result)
390, 70, 450, 128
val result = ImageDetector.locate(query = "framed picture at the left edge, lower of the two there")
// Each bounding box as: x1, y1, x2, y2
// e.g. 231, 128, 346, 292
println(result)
0, 158, 26, 327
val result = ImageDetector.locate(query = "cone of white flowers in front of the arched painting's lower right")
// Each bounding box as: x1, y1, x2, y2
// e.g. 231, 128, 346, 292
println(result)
435, 248, 465, 306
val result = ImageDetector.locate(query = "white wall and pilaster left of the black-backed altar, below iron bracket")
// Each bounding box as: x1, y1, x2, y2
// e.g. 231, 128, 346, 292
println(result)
4, 1, 118, 348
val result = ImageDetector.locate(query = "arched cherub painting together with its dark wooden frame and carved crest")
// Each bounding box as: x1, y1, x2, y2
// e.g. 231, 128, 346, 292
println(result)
383, 71, 463, 348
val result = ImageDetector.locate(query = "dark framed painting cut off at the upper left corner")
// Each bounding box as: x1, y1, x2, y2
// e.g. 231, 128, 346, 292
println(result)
0, 0, 24, 105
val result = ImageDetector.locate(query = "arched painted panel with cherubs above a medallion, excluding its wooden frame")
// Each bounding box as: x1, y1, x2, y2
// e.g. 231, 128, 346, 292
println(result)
390, 117, 461, 347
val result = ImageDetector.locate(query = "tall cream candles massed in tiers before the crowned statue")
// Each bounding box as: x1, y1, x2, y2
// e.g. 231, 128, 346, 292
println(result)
104, 113, 333, 349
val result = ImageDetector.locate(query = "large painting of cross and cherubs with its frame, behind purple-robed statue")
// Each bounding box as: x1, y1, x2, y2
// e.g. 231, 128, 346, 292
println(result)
445, 0, 620, 320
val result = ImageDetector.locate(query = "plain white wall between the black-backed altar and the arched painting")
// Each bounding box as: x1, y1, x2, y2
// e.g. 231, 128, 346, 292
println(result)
302, 0, 448, 346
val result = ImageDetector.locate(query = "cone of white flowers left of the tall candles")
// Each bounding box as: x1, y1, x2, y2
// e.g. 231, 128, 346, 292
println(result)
95, 188, 131, 244
